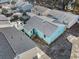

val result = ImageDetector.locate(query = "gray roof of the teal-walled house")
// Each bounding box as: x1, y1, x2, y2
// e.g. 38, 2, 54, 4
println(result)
24, 16, 57, 36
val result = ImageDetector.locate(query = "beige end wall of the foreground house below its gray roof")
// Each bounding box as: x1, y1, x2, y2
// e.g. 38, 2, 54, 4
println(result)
15, 47, 51, 59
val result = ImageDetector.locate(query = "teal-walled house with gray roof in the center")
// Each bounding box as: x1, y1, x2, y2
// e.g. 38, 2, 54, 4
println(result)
23, 16, 66, 44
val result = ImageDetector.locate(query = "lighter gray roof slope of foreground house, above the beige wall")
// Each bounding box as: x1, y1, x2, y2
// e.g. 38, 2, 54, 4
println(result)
0, 27, 36, 55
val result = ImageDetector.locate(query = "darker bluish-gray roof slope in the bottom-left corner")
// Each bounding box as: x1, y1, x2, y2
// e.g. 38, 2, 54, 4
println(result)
0, 32, 15, 59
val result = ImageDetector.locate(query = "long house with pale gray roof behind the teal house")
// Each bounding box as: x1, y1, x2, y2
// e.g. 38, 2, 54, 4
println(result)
32, 6, 78, 28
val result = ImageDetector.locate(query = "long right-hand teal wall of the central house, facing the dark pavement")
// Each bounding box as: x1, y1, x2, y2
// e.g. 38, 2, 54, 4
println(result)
45, 26, 66, 44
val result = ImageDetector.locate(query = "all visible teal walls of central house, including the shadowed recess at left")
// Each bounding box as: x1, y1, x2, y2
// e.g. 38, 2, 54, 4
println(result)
24, 25, 66, 44
